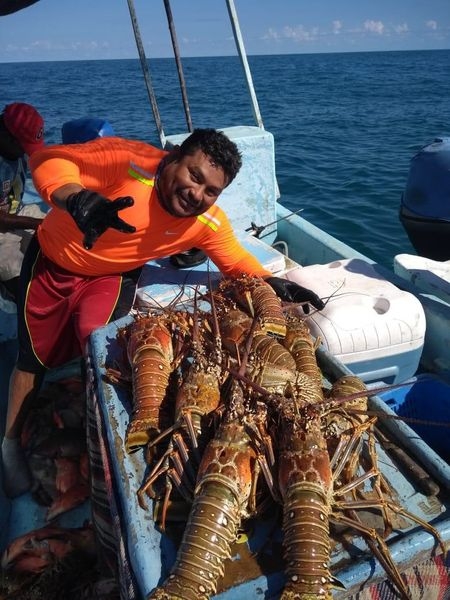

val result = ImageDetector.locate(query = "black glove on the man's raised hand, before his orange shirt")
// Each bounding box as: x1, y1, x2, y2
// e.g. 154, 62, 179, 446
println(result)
67, 190, 136, 250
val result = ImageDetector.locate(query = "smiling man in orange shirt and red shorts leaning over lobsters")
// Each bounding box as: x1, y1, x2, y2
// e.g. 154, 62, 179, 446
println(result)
2, 129, 323, 496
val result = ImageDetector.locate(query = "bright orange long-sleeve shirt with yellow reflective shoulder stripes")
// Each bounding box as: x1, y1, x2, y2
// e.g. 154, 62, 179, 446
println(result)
30, 137, 271, 277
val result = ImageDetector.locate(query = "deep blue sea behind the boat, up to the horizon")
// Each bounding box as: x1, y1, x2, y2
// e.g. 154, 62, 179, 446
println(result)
0, 50, 450, 266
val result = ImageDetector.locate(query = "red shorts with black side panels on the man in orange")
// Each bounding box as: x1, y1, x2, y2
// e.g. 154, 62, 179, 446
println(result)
17, 237, 140, 373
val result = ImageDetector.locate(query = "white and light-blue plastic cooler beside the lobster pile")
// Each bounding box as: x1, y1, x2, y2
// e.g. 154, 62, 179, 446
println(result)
286, 259, 425, 383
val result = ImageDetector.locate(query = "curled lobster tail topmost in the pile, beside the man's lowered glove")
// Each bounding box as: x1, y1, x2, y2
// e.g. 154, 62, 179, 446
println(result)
218, 275, 286, 337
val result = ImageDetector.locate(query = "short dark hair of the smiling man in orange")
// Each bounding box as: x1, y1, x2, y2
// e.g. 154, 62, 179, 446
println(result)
179, 129, 242, 185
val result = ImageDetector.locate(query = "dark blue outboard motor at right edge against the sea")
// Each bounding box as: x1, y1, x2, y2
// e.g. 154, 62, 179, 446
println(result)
400, 137, 450, 261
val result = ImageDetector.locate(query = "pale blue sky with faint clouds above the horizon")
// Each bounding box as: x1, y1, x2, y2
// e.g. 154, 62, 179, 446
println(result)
0, 0, 450, 63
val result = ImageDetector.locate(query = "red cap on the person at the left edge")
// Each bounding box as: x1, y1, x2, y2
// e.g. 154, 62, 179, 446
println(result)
3, 102, 44, 156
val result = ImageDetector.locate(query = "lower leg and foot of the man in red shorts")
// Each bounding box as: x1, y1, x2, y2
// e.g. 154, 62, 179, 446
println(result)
2, 367, 42, 498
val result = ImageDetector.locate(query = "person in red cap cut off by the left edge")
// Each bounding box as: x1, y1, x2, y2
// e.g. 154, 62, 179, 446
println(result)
0, 102, 45, 300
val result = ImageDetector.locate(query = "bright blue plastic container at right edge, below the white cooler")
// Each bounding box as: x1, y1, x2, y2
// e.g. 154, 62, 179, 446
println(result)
378, 374, 450, 462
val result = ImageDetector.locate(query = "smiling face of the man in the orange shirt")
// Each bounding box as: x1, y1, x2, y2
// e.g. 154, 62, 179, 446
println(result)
157, 150, 228, 217
